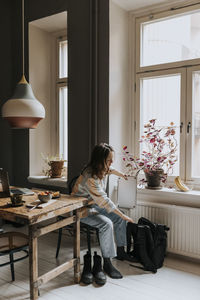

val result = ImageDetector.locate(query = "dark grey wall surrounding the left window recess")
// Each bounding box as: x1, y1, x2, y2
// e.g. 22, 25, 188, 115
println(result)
0, 0, 109, 185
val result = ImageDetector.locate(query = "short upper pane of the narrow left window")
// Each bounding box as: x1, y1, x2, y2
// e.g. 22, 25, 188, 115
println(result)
59, 41, 68, 78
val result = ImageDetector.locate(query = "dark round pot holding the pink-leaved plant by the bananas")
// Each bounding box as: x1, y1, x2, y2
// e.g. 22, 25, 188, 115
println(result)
144, 169, 164, 190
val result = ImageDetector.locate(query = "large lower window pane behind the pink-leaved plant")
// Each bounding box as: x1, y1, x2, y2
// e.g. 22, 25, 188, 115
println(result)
140, 74, 181, 176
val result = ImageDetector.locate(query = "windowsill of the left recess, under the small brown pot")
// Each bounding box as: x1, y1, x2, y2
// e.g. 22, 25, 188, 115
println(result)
27, 176, 67, 188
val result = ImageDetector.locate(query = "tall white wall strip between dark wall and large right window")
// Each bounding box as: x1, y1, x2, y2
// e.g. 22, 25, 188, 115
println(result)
109, 1, 131, 202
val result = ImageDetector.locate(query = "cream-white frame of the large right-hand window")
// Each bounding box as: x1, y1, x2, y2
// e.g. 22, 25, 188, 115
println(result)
134, 4, 200, 187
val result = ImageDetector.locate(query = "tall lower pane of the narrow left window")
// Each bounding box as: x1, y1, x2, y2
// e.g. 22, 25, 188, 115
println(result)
59, 87, 68, 160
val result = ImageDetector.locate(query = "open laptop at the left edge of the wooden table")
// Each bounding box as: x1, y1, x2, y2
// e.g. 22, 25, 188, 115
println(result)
0, 169, 34, 198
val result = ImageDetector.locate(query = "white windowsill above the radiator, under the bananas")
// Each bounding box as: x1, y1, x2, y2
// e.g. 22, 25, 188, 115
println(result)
137, 188, 200, 208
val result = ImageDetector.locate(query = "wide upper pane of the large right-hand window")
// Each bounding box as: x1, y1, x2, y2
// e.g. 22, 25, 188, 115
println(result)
140, 11, 200, 66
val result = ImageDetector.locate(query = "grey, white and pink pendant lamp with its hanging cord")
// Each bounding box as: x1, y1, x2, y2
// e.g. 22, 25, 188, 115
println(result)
2, 0, 45, 128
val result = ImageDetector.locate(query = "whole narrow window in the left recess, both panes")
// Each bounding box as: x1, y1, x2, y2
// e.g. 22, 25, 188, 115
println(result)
56, 37, 68, 164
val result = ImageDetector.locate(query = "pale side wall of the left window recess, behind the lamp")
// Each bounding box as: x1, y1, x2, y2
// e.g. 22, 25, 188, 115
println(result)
29, 24, 55, 175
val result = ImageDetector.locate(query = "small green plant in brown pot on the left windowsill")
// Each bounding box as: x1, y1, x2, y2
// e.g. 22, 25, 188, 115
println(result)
42, 154, 66, 178
